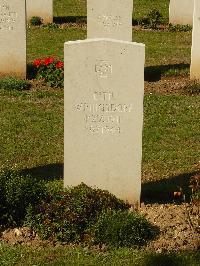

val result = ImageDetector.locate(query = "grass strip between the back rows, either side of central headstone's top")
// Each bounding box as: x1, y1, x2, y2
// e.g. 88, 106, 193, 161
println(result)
28, 27, 191, 67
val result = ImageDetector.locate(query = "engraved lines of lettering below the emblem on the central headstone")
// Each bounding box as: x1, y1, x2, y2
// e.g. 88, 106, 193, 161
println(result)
74, 90, 133, 134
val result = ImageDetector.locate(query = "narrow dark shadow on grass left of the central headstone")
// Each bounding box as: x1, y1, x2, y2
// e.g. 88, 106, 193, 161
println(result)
20, 163, 63, 180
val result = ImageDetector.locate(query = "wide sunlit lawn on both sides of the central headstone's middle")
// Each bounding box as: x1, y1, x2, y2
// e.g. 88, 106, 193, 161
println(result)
0, 90, 200, 183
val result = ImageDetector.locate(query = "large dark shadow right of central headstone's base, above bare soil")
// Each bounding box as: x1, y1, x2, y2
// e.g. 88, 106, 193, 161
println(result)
141, 171, 197, 204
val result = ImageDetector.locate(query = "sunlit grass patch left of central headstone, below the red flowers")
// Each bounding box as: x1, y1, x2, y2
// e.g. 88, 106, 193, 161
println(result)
0, 91, 63, 169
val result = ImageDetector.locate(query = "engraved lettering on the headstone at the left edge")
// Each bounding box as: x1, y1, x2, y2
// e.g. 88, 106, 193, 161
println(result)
0, 3, 18, 31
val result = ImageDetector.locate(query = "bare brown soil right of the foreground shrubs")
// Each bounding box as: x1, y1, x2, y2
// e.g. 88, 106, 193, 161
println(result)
140, 203, 200, 253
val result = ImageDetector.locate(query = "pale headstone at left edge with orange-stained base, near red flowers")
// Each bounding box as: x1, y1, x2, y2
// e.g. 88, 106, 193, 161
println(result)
0, 0, 26, 78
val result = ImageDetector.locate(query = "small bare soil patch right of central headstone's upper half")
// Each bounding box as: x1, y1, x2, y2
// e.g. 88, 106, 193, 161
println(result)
145, 76, 190, 94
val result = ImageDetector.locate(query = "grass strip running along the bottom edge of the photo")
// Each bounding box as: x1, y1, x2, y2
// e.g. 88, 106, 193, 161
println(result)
0, 245, 200, 266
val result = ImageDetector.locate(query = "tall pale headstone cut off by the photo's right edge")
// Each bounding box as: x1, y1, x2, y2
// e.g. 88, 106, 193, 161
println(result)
190, 0, 200, 80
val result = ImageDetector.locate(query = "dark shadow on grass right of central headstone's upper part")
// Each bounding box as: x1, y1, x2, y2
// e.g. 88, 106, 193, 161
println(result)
144, 64, 190, 82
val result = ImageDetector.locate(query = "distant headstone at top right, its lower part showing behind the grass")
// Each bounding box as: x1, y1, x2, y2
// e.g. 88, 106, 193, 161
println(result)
169, 0, 194, 25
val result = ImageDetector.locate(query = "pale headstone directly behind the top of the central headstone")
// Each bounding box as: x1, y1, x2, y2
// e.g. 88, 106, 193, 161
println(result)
87, 0, 133, 41
